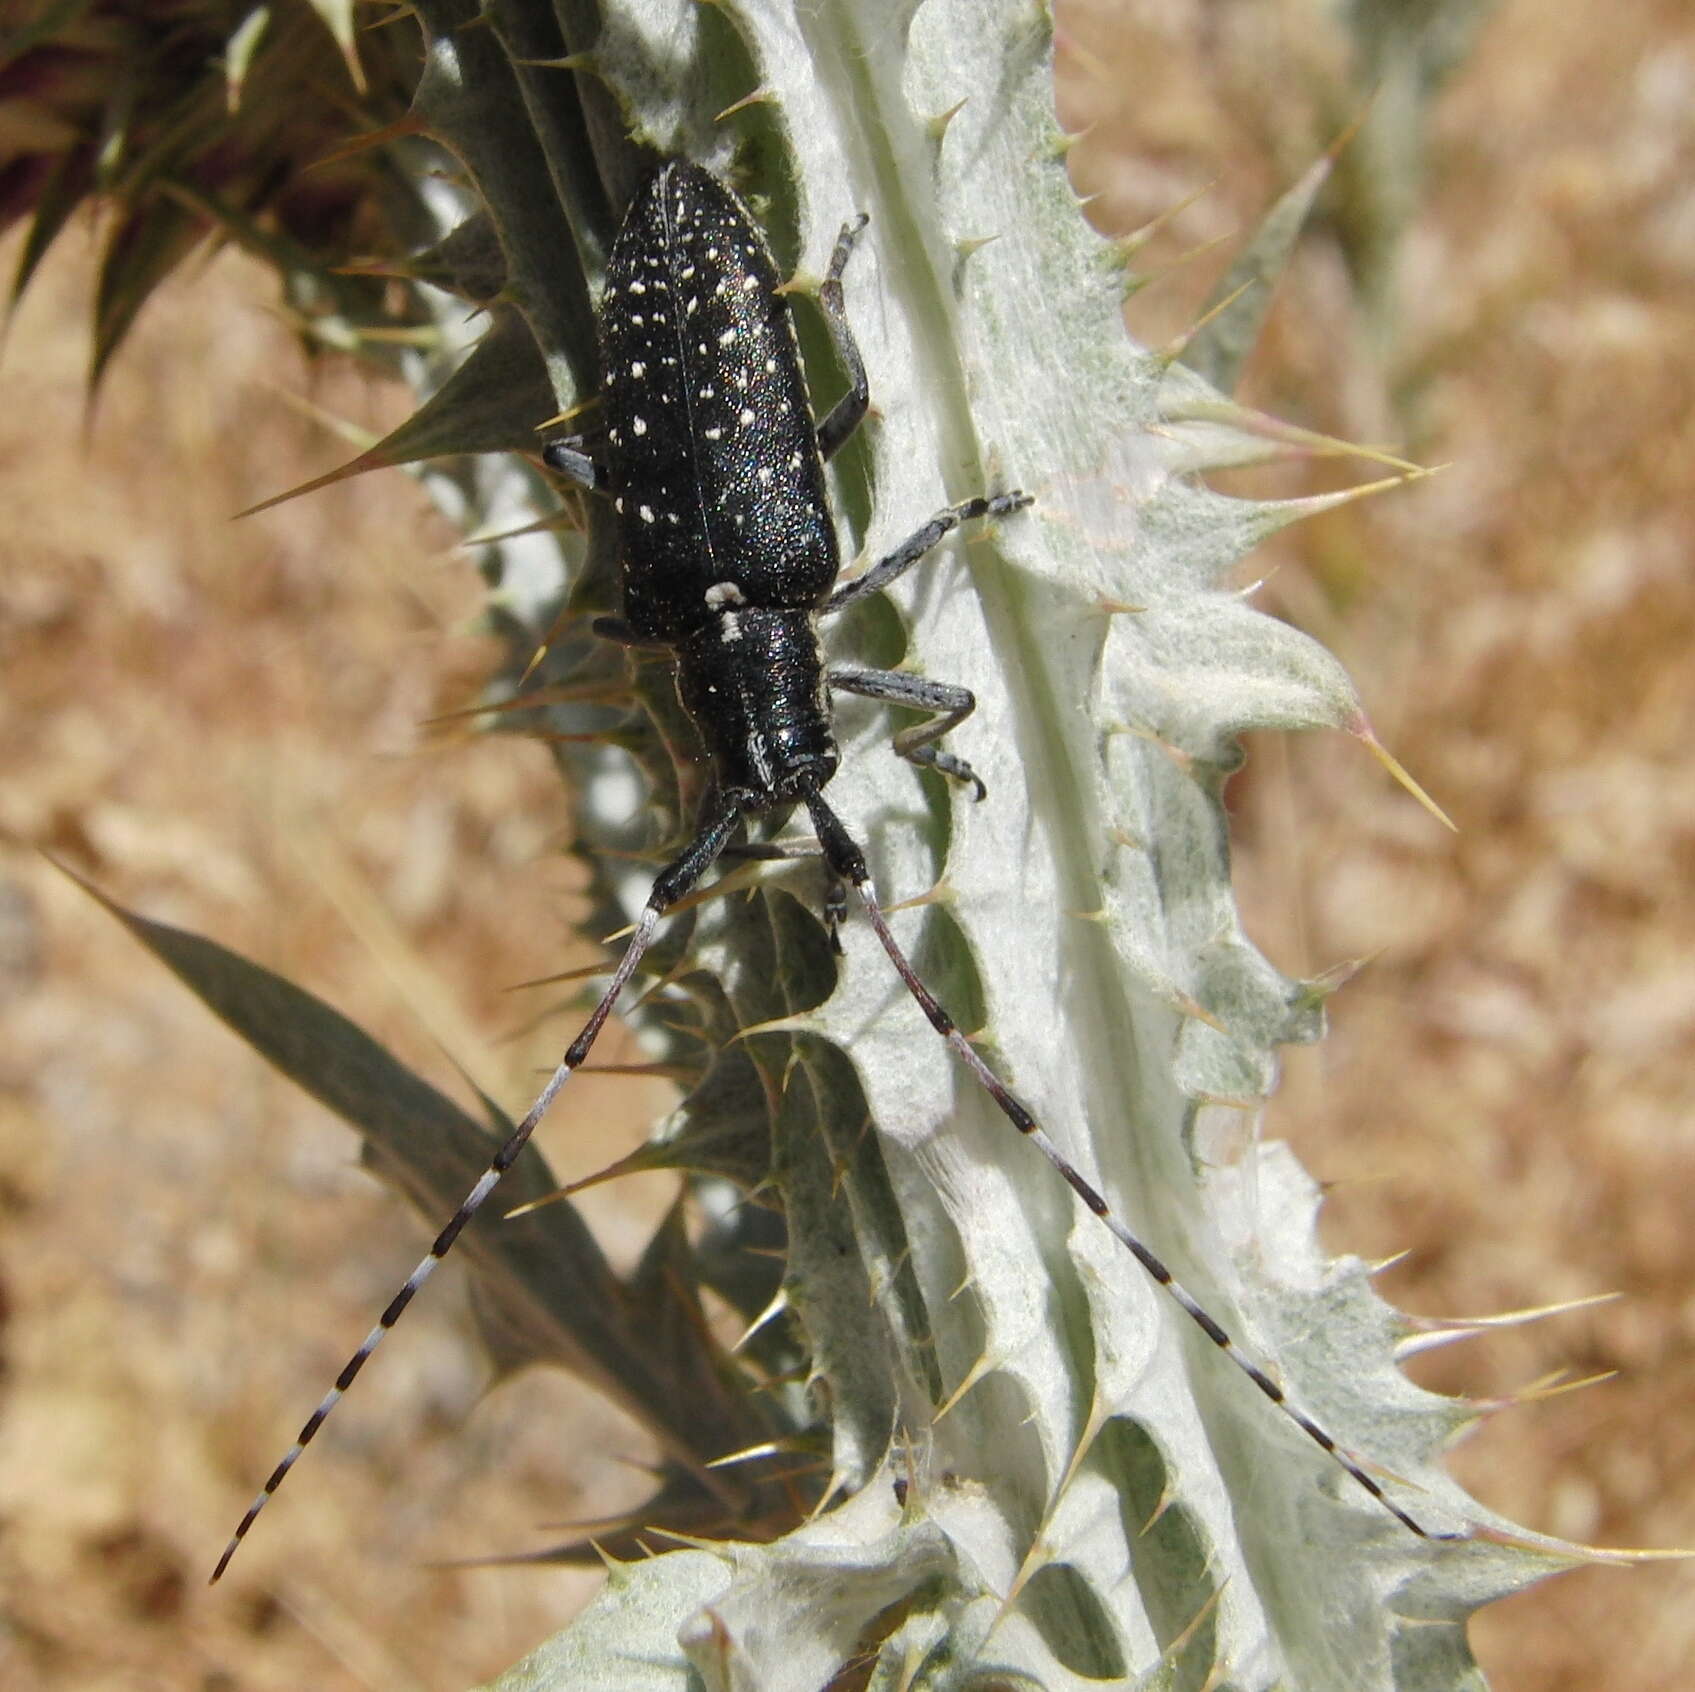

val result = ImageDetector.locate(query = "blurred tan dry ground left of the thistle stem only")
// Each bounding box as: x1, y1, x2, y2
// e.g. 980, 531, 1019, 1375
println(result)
0, 232, 666, 1692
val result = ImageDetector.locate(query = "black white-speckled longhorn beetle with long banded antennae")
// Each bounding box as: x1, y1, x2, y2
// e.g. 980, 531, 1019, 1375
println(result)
212, 163, 1432, 1580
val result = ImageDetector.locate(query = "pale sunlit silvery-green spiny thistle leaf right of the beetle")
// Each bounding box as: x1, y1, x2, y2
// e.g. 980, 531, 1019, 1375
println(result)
454, 0, 1575, 1692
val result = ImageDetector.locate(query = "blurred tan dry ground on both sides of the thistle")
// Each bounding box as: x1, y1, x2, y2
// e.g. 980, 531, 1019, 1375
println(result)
0, 0, 1695, 1692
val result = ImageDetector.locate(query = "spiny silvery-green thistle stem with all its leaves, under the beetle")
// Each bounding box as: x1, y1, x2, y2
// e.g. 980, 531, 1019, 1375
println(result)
6, 0, 1606, 1692
